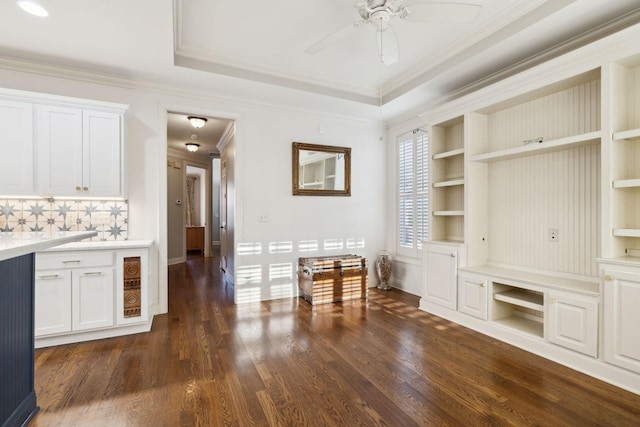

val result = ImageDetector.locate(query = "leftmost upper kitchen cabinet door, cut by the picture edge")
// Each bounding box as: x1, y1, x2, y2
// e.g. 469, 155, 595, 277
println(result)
0, 100, 35, 196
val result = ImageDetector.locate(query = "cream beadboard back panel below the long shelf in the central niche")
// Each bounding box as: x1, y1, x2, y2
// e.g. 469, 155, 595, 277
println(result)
488, 145, 600, 276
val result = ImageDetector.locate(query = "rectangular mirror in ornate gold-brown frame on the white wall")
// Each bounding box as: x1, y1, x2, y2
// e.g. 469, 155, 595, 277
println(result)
292, 142, 351, 196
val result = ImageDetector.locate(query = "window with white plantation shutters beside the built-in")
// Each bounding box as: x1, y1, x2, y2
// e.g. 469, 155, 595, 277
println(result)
397, 131, 429, 256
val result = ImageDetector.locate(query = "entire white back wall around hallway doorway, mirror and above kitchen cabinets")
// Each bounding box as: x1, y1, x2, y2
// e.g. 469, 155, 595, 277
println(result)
0, 69, 386, 312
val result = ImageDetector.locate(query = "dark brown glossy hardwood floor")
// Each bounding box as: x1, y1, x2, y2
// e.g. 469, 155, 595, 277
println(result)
31, 252, 640, 427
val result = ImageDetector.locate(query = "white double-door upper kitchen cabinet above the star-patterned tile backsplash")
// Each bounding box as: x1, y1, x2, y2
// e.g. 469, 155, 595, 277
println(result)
35, 105, 124, 197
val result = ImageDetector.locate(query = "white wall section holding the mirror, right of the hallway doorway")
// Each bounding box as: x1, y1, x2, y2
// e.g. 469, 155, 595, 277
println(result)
236, 105, 386, 302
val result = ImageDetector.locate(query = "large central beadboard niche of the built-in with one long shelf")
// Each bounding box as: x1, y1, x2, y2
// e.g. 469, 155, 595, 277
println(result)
465, 70, 603, 276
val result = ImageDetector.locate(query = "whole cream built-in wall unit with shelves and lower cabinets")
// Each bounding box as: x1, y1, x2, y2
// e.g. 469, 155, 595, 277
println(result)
420, 31, 640, 392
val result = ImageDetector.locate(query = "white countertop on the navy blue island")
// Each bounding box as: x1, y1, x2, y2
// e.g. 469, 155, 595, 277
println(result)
0, 231, 98, 261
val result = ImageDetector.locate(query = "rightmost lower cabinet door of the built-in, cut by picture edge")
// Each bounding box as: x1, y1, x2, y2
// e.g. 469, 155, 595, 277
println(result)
604, 270, 640, 373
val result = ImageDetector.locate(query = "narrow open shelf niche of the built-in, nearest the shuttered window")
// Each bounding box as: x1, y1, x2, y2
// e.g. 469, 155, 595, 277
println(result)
429, 117, 465, 242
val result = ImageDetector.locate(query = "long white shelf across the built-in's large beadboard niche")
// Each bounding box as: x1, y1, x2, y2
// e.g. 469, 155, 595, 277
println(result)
471, 131, 602, 162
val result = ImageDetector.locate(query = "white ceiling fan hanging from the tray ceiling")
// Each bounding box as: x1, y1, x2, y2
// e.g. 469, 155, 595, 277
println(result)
305, 0, 482, 65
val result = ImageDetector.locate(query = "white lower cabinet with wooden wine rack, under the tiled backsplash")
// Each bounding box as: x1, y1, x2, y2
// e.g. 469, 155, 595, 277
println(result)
34, 248, 150, 347
